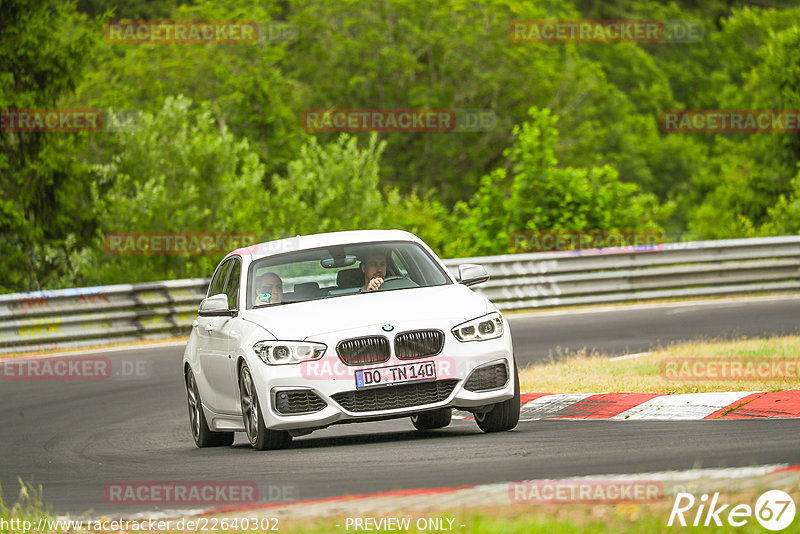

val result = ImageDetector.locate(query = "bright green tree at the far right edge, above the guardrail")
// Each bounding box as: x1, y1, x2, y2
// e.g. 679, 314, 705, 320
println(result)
685, 9, 800, 238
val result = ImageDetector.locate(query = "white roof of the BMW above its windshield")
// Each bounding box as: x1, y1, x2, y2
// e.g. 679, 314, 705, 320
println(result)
225, 230, 425, 261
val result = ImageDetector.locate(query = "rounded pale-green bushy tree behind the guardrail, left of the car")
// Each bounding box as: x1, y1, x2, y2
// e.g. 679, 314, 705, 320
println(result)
73, 97, 268, 284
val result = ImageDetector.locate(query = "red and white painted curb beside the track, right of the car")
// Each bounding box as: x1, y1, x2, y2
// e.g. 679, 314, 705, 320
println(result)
453, 390, 800, 421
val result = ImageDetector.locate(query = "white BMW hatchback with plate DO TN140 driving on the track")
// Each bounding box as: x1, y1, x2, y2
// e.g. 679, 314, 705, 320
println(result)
183, 230, 520, 450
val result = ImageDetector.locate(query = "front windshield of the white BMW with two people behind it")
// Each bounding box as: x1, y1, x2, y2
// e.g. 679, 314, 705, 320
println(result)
247, 241, 452, 308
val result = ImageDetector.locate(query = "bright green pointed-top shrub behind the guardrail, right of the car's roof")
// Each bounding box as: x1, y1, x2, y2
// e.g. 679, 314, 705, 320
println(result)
450, 108, 664, 255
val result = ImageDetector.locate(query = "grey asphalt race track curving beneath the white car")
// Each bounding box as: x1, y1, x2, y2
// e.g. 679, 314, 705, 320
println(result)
0, 298, 800, 515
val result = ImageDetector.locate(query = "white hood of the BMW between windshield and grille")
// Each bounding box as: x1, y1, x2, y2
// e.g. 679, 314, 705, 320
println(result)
240, 284, 490, 340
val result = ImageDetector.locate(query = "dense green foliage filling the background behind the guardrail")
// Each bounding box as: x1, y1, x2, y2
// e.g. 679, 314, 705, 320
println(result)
0, 0, 800, 292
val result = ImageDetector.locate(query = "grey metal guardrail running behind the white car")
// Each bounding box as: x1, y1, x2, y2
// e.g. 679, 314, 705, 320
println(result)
0, 236, 800, 354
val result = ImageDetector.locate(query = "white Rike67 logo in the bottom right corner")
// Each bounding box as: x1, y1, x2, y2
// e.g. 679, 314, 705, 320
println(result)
667, 490, 796, 531
